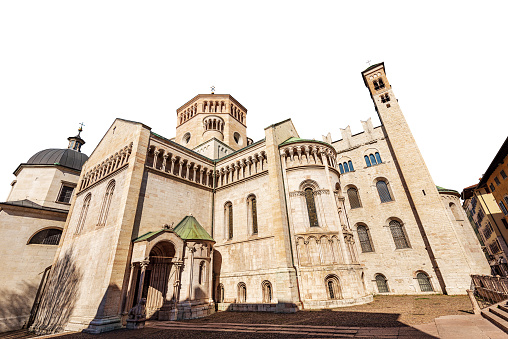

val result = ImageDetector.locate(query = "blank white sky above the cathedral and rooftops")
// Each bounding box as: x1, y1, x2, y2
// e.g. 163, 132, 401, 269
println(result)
0, 0, 508, 201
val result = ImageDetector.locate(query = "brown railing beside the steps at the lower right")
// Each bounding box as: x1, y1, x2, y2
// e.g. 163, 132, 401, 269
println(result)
471, 275, 508, 308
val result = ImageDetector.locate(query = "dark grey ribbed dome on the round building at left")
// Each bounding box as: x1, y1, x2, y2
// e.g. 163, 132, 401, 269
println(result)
27, 148, 88, 171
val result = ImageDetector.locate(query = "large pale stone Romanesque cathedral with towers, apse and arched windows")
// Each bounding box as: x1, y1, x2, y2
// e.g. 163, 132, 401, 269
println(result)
0, 63, 490, 333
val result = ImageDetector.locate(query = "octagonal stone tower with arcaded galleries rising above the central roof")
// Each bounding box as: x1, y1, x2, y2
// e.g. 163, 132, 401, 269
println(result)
175, 92, 247, 151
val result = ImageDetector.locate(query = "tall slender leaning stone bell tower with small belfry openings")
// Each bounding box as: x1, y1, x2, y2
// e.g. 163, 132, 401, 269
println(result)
362, 63, 478, 294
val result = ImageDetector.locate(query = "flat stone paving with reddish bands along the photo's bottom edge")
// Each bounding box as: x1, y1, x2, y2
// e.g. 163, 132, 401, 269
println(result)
0, 315, 508, 339
